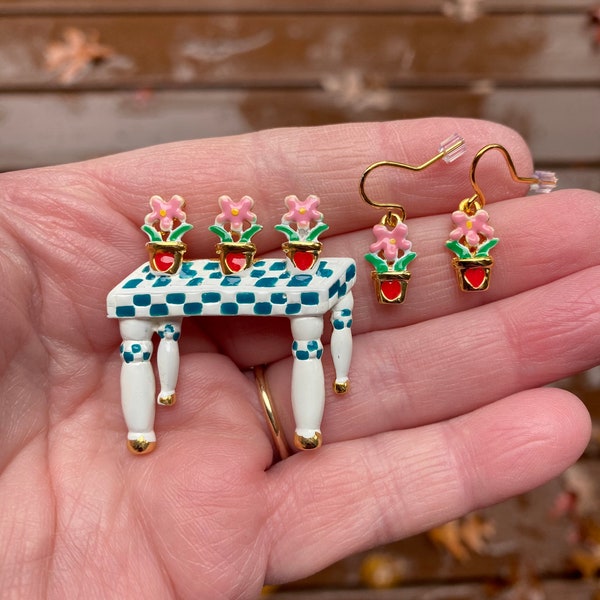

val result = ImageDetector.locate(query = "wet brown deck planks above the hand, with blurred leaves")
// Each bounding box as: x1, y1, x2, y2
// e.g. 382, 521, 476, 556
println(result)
0, 0, 600, 189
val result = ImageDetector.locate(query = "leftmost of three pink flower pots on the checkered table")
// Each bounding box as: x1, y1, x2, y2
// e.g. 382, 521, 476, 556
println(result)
142, 195, 193, 275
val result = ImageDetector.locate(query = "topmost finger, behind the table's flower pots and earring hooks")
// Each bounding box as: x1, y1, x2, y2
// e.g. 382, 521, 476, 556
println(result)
84, 118, 531, 256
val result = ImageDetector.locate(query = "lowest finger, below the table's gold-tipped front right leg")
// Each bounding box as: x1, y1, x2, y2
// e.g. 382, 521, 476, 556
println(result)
268, 389, 590, 583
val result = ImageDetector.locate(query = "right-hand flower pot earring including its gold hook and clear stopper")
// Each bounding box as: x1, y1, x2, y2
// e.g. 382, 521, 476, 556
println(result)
446, 144, 557, 292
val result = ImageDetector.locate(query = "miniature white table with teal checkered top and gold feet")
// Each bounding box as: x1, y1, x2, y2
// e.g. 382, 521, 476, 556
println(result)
107, 258, 356, 453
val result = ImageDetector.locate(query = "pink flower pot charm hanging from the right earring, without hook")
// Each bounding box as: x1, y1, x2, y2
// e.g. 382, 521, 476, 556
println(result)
446, 199, 500, 292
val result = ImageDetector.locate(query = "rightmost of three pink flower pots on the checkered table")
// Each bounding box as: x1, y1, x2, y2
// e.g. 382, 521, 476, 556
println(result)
275, 194, 329, 271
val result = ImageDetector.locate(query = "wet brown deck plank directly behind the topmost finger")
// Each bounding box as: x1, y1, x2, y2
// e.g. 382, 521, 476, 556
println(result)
0, 89, 600, 171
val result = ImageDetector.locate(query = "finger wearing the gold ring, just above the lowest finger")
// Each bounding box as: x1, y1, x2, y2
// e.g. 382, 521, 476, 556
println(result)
267, 266, 600, 442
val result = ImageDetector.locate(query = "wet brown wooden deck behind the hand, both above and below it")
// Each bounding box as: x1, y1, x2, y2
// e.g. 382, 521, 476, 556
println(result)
0, 0, 600, 600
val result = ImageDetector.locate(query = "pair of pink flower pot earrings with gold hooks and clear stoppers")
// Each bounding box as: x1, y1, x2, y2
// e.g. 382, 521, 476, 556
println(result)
359, 134, 557, 304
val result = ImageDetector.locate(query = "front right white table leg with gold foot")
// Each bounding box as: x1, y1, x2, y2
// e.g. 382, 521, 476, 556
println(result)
291, 316, 325, 450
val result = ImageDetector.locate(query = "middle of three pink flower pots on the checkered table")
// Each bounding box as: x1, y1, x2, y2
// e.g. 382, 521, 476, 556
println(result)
209, 196, 262, 275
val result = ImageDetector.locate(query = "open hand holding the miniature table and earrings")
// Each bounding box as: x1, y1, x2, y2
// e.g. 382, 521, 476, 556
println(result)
0, 119, 600, 600
